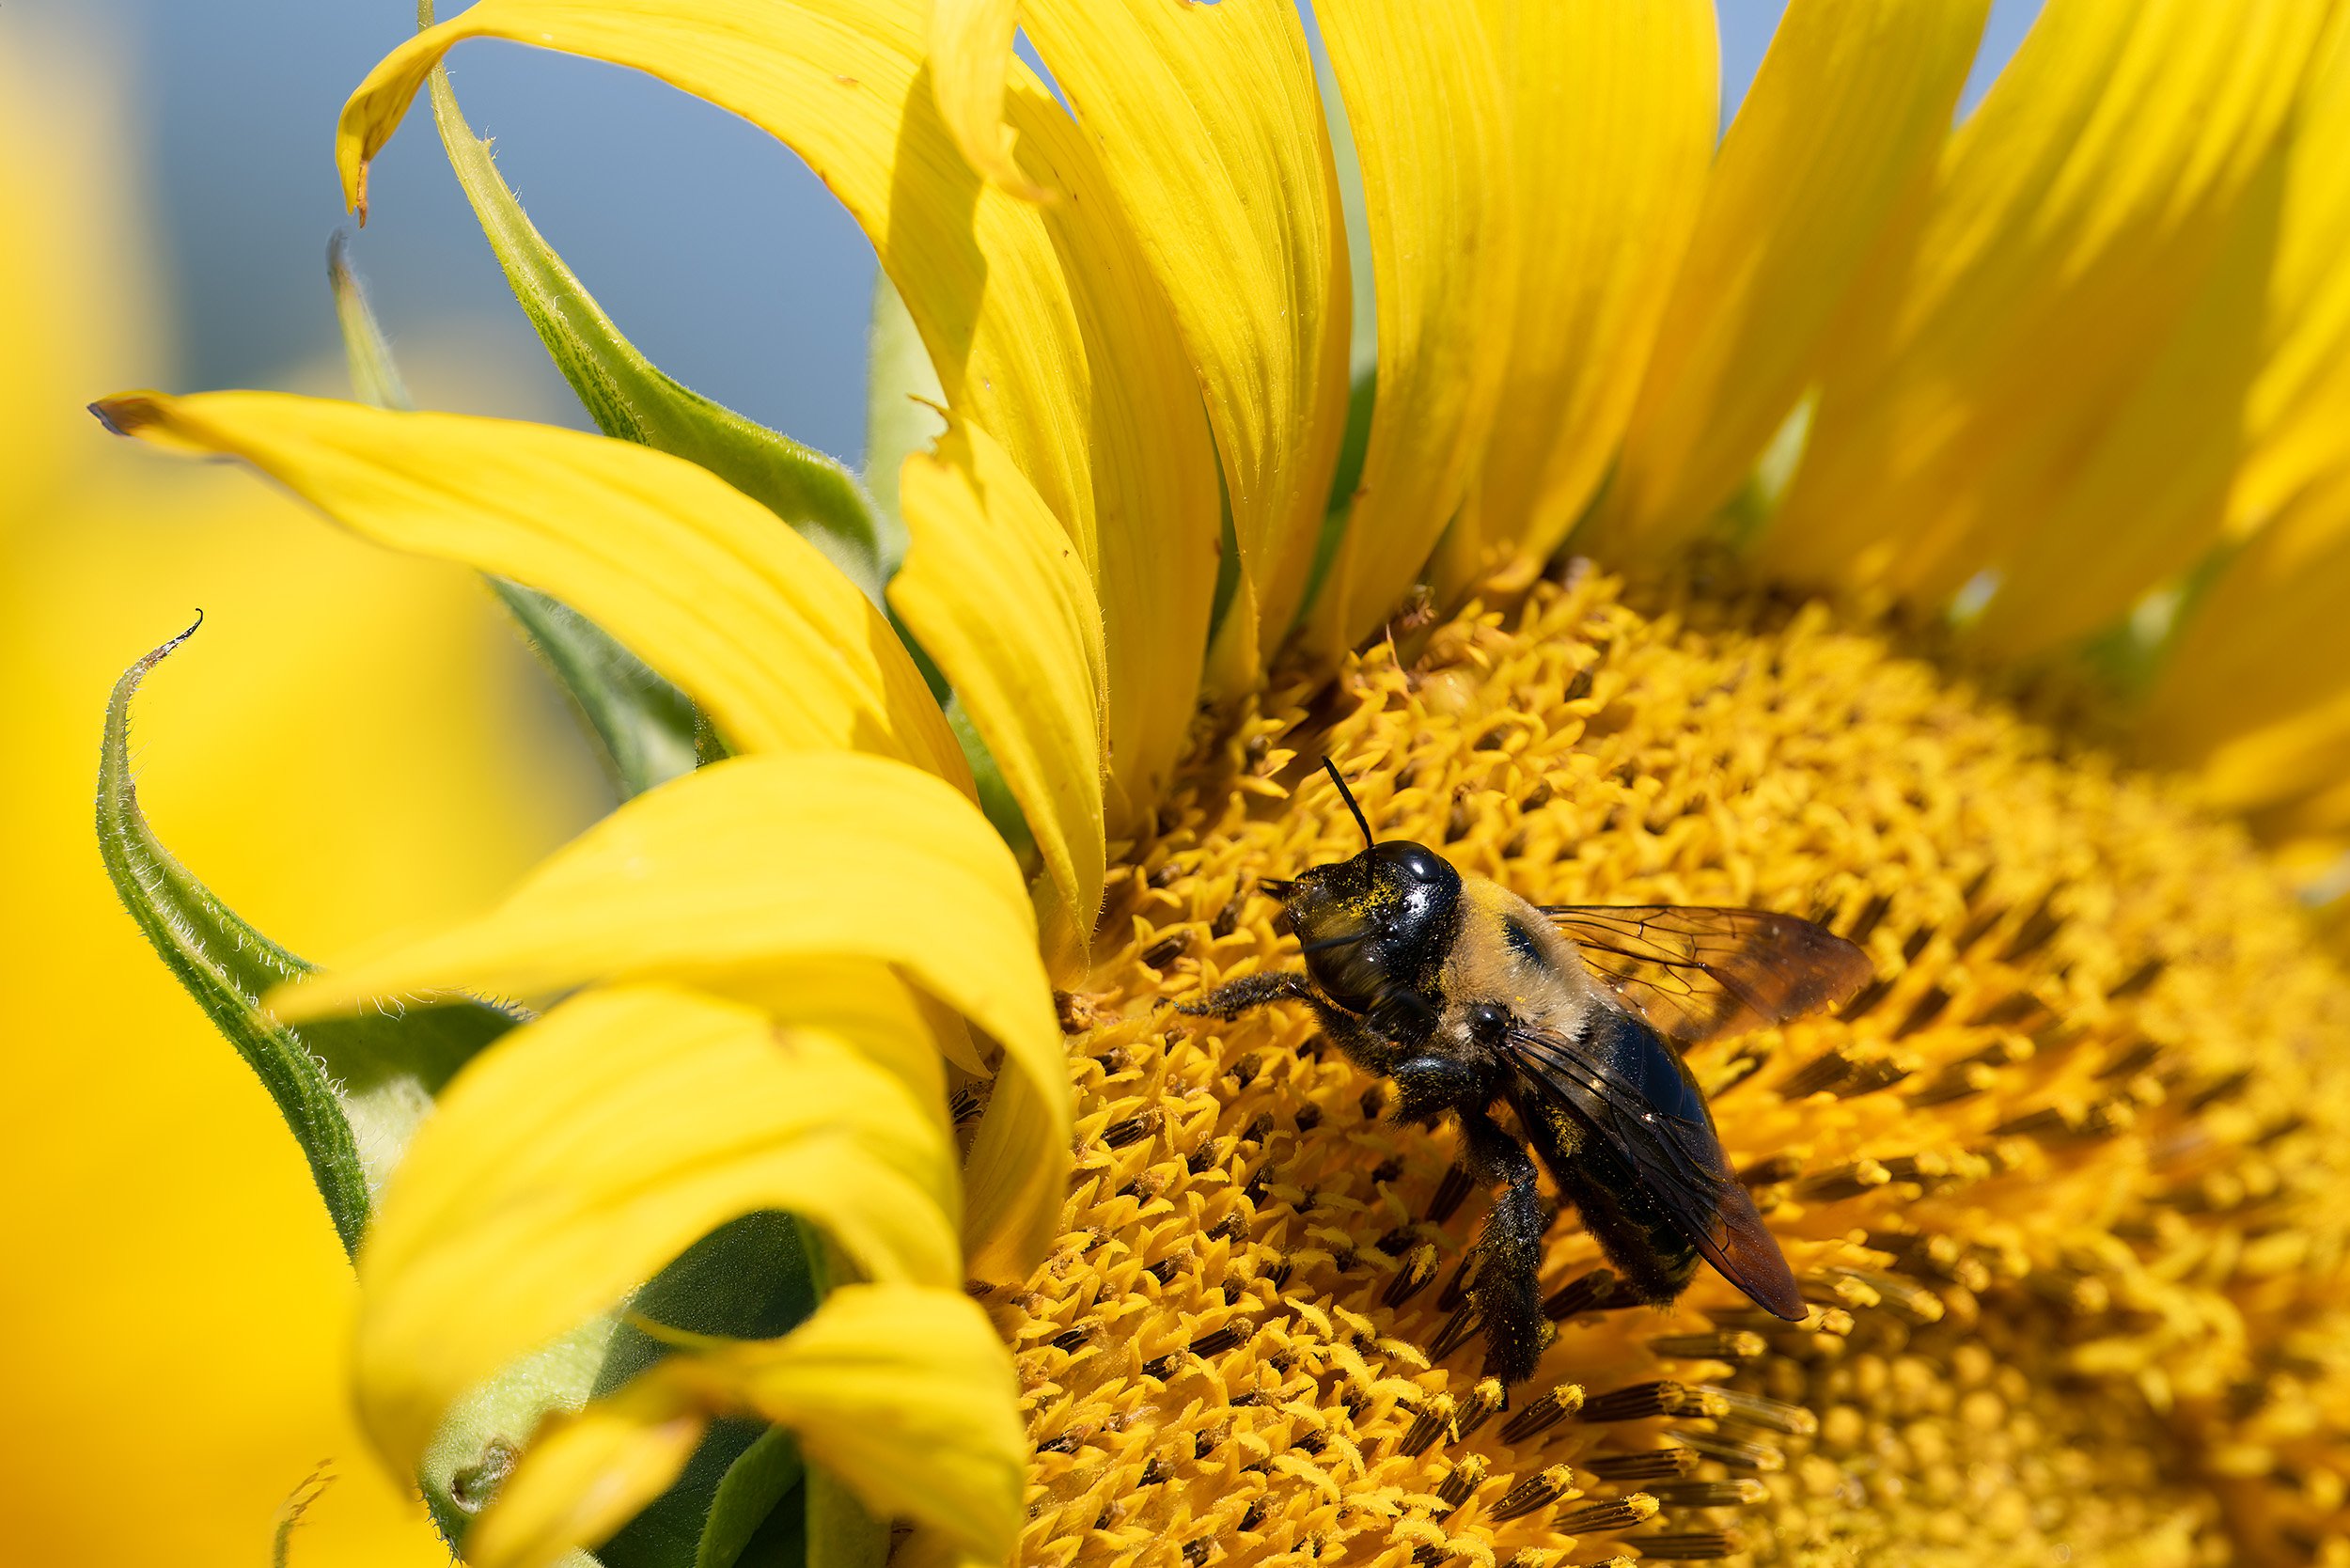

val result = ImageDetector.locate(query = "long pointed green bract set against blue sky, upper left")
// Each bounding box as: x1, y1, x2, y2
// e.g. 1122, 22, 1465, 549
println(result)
418, 50, 884, 604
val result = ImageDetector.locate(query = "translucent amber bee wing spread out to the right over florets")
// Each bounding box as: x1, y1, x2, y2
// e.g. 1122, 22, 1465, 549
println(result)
1542, 902, 1875, 1043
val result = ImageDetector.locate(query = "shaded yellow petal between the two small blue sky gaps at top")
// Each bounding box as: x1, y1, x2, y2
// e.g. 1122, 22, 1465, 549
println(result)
1603, 0, 1988, 555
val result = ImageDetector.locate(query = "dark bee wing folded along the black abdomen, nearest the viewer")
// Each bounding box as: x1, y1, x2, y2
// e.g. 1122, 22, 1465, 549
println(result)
1507, 1009, 1803, 1321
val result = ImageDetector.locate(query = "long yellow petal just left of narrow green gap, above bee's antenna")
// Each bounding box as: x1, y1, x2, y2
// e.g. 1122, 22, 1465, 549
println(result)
1020, 0, 1349, 680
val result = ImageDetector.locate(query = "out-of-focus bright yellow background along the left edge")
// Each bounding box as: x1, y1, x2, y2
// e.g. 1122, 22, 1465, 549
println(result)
0, 24, 597, 1568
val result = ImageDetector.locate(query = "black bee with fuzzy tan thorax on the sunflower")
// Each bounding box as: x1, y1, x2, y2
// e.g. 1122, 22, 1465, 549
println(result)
1180, 757, 1871, 1382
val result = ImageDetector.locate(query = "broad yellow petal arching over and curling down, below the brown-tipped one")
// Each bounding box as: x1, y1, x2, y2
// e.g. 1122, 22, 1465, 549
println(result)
271, 752, 1070, 1277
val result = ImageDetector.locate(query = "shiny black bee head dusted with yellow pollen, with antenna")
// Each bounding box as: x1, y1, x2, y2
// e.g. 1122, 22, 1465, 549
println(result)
1267, 760, 1462, 1013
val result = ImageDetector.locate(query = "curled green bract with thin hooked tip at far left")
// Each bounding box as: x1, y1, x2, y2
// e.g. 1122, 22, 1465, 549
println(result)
99, 619, 517, 1255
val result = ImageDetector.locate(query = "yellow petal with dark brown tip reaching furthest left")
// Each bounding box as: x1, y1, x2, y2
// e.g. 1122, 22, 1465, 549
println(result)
99, 393, 971, 792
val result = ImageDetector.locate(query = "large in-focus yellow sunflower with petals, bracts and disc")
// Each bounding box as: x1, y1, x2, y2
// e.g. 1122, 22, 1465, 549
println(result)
102, 0, 2350, 1568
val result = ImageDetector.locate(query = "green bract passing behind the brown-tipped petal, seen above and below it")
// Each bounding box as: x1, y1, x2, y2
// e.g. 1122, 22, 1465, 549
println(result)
327, 230, 696, 799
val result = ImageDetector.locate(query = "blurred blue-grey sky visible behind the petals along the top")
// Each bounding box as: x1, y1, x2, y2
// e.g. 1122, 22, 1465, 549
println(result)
50, 0, 2040, 461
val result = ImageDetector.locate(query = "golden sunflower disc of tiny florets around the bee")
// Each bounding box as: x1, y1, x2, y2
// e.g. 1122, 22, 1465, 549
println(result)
985, 569, 2350, 1568
